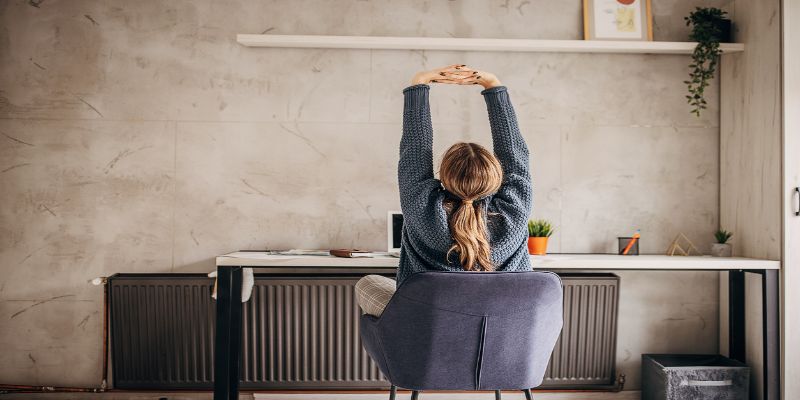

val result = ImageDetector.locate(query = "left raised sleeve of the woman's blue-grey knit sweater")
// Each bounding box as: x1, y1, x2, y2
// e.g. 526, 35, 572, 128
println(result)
397, 84, 450, 262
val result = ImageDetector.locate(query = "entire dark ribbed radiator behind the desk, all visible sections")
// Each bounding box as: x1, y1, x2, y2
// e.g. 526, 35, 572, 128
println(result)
109, 274, 619, 390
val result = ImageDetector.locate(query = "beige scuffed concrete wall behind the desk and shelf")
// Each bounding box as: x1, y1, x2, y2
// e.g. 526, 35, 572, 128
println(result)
0, 0, 727, 388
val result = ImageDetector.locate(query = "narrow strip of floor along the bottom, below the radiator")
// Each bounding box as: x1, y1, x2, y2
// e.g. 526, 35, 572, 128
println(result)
2, 391, 640, 400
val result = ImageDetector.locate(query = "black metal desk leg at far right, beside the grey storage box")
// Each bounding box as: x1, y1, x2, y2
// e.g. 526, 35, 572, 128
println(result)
761, 269, 781, 400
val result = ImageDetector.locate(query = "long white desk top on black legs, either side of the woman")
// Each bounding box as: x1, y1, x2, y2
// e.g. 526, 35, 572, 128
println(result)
217, 251, 781, 271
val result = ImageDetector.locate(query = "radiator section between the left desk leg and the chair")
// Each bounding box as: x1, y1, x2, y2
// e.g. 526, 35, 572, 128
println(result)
241, 278, 388, 388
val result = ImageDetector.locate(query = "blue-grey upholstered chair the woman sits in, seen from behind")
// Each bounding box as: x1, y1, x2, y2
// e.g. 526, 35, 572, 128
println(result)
360, 272, 563, 390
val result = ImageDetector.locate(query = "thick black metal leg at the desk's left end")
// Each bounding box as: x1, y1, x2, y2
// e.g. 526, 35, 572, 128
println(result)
214, 266, 242, 400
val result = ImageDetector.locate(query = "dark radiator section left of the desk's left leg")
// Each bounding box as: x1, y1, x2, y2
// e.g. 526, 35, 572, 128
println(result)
108, 274, 215, 389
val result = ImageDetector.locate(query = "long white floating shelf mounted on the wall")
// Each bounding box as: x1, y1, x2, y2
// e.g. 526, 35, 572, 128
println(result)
236, 34, 744, 54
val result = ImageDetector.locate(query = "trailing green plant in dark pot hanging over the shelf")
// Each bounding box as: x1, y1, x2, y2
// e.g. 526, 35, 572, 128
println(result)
683, 7, 731, 117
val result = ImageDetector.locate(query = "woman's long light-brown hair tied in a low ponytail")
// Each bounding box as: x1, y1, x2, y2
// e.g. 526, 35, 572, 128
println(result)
439, 142, 503, 271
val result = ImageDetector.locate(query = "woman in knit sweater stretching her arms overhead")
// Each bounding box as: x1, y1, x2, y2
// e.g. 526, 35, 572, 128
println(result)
356, 64, 531, 316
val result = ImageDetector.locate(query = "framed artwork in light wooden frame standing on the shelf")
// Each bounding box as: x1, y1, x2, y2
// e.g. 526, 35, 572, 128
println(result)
583, 0, 653, 40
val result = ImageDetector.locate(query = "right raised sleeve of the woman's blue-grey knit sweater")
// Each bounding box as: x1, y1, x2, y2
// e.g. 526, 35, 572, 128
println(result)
481, 86, 532, 234
